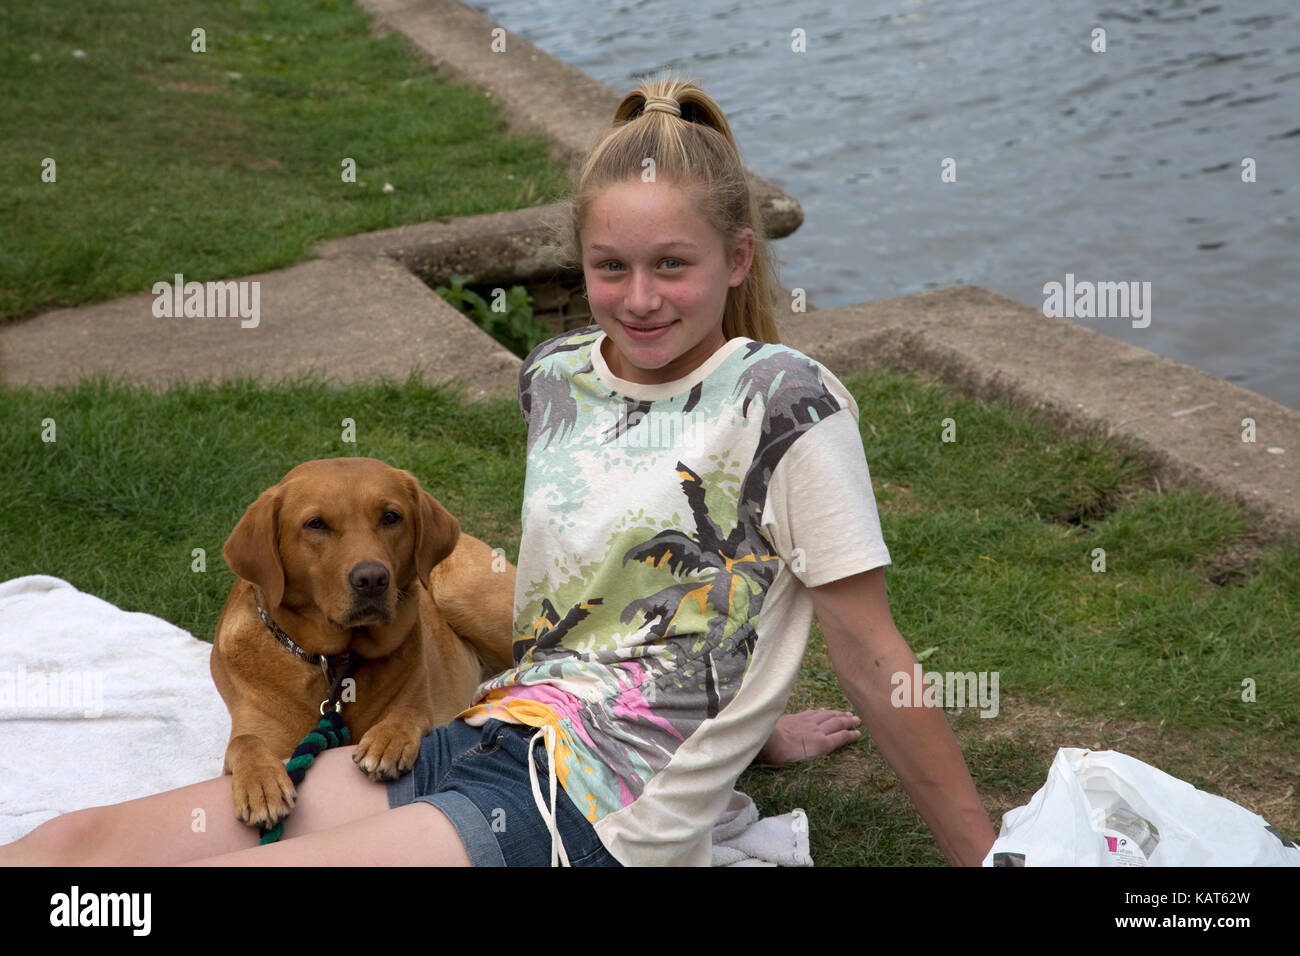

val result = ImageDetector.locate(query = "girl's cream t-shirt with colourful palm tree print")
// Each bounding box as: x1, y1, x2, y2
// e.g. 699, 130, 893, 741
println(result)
462, 325, 889, 865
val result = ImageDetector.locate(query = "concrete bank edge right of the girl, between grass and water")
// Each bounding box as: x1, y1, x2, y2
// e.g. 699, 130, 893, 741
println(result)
779, 286, 1300, 542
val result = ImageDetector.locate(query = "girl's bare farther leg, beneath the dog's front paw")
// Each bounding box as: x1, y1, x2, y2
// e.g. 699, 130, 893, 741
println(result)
0, 747, 436, 866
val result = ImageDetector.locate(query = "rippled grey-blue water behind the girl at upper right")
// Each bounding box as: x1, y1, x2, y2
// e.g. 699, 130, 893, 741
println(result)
473, 0, 1300, 408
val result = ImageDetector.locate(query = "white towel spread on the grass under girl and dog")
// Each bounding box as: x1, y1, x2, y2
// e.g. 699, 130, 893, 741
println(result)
0, 575, 813, 866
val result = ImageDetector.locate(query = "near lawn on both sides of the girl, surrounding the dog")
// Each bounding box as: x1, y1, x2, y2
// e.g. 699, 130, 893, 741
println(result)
0, 373, 1300, 865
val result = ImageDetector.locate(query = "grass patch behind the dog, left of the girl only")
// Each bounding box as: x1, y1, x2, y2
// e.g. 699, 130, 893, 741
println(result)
0, 378, 525, 640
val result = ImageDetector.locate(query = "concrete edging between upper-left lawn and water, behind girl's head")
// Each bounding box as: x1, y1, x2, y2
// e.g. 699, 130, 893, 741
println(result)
359, 0, 803, 239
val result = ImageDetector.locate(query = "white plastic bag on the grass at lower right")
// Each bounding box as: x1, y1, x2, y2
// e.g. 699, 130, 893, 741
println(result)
984, 747, 1300, 866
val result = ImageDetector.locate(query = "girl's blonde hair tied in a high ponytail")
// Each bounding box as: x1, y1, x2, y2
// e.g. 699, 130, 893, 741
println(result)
556, 73, 780, 343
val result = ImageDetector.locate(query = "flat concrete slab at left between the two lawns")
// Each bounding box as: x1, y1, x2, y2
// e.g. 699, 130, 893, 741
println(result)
0, 256, 520, 398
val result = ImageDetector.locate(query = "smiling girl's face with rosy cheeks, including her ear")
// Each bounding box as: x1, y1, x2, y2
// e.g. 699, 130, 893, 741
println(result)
582, 179, 754, 385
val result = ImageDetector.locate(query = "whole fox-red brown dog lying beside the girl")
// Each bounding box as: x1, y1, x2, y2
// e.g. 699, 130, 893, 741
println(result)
212, 458, 515, 826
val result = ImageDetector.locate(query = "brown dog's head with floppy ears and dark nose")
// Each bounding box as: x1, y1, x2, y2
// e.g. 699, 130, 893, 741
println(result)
222, 458, 460, 653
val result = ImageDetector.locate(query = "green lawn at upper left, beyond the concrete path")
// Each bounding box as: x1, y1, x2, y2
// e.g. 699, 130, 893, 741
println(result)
0, 0, 567, 320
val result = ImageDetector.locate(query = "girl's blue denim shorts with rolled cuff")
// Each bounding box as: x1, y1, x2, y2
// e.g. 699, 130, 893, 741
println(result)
389, 719, 621, 866
